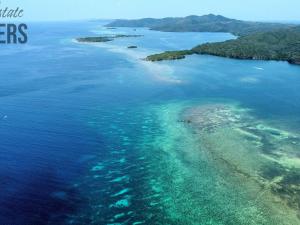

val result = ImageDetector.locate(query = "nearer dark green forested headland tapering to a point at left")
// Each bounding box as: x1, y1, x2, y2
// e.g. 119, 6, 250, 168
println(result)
147, 27, 300, 65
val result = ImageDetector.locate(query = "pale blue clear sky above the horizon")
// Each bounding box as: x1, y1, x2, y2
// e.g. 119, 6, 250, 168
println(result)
0, 0, 300, 21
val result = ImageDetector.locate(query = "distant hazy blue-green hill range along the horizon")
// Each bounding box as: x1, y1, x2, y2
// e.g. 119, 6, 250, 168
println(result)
106, 14, 295, 36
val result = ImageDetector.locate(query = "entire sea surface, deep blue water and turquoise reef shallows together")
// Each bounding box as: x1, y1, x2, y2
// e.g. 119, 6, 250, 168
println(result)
0, 22, 300, 225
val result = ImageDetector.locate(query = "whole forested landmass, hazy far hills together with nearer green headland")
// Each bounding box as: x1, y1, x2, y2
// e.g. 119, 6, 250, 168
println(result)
107, 14, 300, 64
